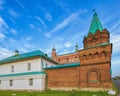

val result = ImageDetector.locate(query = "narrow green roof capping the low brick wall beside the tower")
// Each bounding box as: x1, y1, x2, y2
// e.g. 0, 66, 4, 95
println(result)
44, 62, 80, 70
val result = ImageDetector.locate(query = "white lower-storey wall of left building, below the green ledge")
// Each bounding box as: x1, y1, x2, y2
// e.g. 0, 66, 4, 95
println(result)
0, 74, 45, 91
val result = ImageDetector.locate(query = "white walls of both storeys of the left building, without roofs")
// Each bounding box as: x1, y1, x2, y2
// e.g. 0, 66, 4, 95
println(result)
0, 57, 55, 90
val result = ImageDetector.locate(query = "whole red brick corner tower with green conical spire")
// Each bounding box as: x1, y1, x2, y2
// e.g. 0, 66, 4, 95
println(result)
78, 13, 112, 88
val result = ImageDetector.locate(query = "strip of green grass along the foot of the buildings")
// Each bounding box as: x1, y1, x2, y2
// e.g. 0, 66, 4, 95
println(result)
0, 91, 116, 96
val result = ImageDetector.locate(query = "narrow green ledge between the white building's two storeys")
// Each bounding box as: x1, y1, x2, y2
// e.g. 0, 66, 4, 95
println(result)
0, 71, 46, 77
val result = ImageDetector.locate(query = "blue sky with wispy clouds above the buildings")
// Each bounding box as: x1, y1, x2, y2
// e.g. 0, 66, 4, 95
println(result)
0, 0, 120, 76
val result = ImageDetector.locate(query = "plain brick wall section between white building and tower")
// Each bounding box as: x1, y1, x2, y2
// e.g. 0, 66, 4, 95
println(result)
46, 67, 79, 88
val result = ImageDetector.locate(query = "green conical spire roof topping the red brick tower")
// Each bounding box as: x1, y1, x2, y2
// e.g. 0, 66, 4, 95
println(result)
89, 12, 103, 34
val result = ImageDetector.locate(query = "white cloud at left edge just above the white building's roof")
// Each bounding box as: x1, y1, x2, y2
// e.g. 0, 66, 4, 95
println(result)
0, 47, 13, 59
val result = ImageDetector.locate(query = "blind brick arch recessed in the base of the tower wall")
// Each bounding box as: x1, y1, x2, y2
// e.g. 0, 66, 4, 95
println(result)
87, 69, 100, 87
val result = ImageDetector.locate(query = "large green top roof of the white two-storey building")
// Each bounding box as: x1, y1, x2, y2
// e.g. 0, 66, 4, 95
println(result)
0, 50, 56, 64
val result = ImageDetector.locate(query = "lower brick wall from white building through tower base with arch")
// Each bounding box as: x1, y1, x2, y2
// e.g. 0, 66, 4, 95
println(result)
46, 63, 111, 88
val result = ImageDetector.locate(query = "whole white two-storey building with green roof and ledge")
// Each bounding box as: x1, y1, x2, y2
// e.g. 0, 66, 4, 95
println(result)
0, 50, 56, 91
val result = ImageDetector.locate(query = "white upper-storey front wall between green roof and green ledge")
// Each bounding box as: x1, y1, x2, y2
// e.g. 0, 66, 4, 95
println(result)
0, 58, 42, 75
